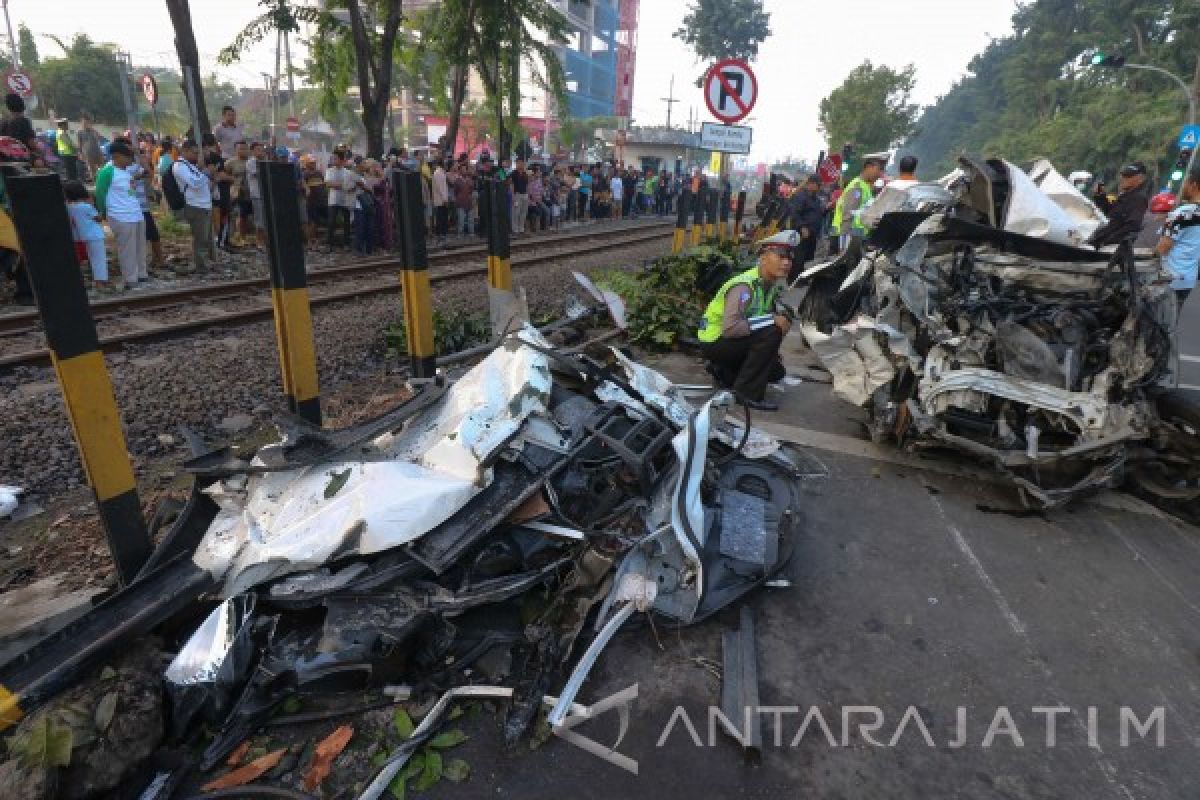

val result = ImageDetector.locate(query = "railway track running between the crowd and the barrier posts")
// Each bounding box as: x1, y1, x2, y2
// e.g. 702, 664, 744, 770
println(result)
0, 222, 673, 368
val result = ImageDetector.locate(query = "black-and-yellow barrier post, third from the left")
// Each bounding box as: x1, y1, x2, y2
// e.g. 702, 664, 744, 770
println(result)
392, 169, 437, 378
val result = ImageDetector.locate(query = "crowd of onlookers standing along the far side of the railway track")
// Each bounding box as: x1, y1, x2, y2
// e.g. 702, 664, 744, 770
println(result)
0, 100, 696, 298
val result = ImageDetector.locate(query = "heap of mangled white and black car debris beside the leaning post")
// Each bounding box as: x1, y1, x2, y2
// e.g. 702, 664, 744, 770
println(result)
0, 327, 800, 798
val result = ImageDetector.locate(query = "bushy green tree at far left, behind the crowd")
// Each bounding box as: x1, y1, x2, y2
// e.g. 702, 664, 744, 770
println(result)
37, 34, 125, 125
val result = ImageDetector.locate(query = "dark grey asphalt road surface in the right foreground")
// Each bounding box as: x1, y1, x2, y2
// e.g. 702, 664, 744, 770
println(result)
437, 335, 1200, 800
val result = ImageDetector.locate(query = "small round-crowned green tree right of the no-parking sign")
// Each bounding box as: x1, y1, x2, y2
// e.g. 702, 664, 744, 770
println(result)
817, 61, 919, 152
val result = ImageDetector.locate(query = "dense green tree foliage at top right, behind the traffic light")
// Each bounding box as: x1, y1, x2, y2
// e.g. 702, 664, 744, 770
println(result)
906, 0, 1200, 183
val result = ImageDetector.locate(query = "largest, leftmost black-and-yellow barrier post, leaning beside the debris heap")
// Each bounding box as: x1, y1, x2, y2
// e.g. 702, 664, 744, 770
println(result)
0, 175, 154, 587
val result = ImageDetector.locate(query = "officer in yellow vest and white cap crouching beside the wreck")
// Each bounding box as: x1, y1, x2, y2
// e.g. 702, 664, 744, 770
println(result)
696, 230, 800, 411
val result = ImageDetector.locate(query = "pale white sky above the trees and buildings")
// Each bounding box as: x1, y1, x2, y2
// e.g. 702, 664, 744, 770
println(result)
7, 0, 1016, 161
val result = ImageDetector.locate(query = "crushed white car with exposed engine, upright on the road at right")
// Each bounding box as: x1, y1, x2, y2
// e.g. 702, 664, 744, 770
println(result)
797, 160, 1200, 513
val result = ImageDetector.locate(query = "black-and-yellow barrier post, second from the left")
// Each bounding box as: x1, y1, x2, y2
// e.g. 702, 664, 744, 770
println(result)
258, 161, 320, 426
